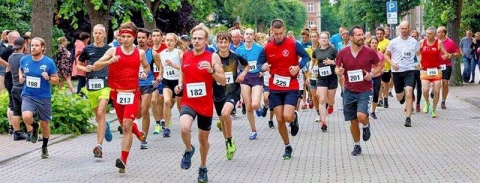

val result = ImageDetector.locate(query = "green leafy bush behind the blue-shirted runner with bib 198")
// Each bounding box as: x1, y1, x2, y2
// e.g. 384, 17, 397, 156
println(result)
0, 87, 94, 135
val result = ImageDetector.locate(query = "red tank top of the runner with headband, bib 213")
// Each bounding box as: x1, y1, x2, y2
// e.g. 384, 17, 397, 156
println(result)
108, 46, 140, 90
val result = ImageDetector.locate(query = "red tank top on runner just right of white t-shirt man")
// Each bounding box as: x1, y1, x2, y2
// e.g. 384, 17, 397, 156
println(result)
420, 39, 440, 71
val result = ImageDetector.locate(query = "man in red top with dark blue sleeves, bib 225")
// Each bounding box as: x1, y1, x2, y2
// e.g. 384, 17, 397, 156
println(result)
257, 19, 310, 160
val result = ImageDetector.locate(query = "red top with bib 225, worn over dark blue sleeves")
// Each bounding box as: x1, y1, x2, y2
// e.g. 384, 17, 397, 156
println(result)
265, 38, 302, 91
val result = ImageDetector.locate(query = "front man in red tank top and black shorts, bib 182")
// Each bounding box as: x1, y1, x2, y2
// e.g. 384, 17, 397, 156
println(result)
175, 26, 227, 182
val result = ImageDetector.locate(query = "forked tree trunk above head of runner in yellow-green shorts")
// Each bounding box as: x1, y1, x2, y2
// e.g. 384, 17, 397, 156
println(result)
84, 0, 110, 41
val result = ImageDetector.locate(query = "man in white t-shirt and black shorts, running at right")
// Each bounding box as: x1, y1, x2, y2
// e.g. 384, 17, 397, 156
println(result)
385, 21, 422, 127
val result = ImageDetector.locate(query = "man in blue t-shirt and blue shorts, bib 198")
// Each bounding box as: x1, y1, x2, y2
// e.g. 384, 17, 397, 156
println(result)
18, 37, 58, 158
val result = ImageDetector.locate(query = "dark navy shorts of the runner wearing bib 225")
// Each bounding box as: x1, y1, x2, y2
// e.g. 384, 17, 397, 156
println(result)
268, 90, 300, 109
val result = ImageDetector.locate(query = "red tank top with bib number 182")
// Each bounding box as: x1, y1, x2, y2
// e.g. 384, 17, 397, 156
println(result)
181, 51, 215, 117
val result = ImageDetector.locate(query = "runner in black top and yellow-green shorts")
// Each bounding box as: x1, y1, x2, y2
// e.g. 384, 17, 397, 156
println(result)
77, 24, 113, 158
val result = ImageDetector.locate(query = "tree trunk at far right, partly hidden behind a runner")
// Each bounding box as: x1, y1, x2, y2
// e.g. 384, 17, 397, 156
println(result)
447, 0, 463, 86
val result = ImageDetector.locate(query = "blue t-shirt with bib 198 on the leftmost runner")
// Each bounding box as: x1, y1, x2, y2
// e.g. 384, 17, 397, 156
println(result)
20, 55, 57, 99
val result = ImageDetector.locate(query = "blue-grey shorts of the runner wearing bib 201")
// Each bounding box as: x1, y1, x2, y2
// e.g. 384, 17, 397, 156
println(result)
343, 88, 373, 121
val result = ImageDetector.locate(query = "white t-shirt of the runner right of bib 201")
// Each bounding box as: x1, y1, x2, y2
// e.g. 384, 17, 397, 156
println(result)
387, 36, 420, 72
